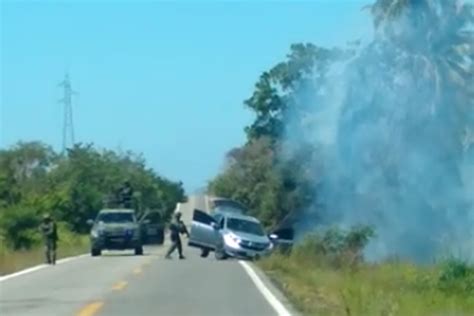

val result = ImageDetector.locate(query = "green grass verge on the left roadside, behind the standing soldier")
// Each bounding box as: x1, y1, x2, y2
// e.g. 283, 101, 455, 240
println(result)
0, 233, 89, 275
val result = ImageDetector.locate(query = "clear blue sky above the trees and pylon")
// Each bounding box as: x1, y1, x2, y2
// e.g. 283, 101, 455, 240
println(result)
0, 0, 371, 191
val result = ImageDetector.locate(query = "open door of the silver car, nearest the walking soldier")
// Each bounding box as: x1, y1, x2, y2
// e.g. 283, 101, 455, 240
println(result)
188, 209, 219, 249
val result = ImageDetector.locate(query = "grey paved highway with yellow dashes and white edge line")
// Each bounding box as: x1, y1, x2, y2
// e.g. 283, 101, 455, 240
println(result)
0, 197, 294, 316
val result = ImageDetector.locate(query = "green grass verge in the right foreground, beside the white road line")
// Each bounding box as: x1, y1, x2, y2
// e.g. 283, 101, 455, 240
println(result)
259, 253, 474, 316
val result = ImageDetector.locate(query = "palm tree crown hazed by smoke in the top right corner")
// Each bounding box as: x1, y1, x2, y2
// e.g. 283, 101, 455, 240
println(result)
369, 0, 474, 113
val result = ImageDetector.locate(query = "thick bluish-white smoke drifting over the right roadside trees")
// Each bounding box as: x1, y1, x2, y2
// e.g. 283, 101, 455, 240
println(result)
285, 3, 474, 262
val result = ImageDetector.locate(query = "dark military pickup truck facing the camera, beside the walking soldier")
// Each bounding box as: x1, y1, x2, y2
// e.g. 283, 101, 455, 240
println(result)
88, 209, 143, 256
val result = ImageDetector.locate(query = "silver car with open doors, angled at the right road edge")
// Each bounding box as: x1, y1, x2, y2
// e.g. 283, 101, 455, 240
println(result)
188, 210, 274, 260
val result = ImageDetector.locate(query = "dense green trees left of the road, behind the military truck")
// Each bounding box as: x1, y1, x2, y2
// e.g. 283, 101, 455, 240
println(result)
0, 142, 185, 249
